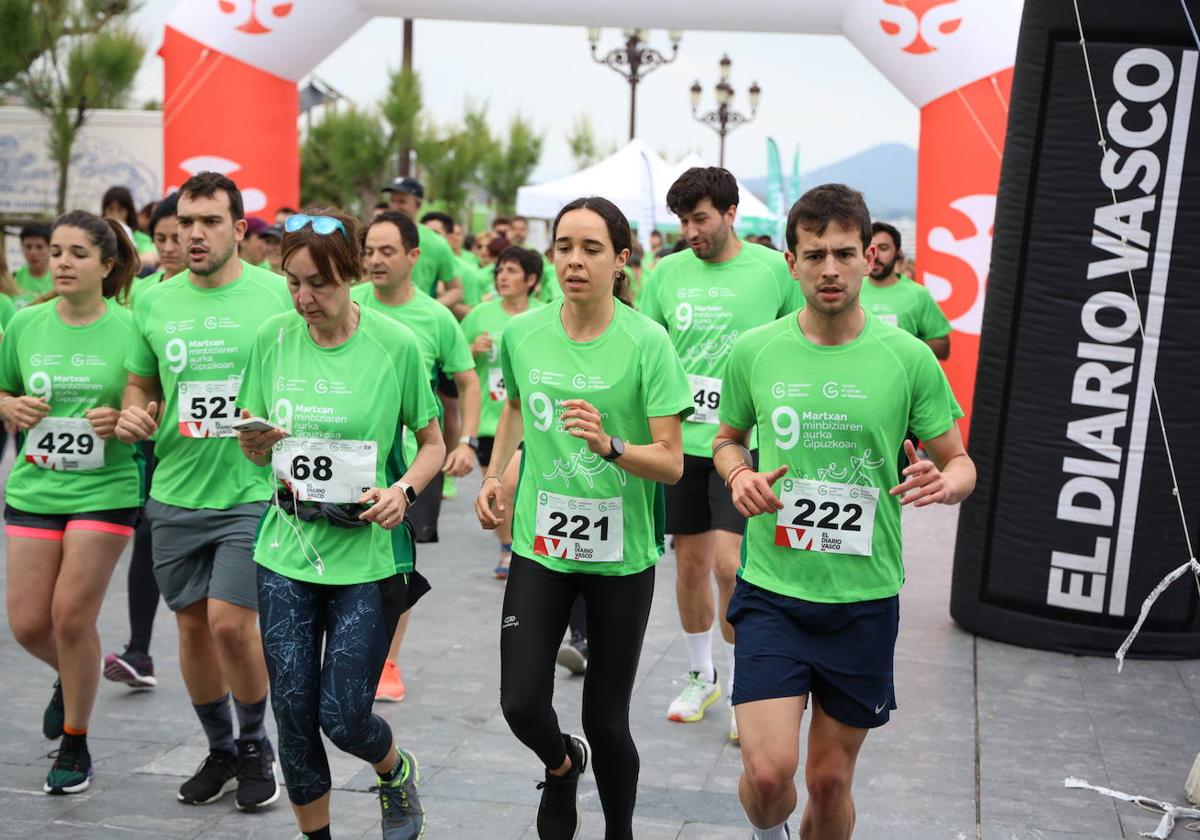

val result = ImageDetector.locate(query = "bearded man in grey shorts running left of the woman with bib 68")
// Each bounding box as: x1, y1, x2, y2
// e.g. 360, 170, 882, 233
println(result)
116, 172, 290, 811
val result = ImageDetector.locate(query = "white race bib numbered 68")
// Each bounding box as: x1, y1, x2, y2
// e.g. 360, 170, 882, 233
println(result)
271, 438, 378, 504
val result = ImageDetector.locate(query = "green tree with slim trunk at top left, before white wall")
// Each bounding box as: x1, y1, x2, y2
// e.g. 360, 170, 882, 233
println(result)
16, 9, 145, 214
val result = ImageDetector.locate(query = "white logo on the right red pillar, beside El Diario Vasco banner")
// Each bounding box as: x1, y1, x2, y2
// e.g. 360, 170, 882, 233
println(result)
924, 193, 996, 335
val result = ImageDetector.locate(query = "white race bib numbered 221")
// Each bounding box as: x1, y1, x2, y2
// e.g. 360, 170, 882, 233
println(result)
533, 491, 625, 563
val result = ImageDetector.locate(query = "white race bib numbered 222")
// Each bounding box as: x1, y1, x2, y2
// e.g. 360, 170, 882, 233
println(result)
775, 479, 880, 557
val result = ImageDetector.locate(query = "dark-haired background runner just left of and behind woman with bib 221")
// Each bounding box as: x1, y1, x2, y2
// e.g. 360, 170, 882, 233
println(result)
462, 246, 541, 578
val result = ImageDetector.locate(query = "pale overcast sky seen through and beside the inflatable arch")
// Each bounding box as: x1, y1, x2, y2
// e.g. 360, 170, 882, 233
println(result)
134, 0, 918, 180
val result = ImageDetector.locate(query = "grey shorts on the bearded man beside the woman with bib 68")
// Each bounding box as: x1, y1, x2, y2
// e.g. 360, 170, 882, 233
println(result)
145, 499, 268, 612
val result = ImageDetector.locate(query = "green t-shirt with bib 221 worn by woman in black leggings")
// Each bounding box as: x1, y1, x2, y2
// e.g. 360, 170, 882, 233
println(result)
500, 302, 694, 575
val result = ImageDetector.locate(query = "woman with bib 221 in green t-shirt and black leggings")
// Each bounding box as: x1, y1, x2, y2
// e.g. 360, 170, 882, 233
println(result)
475, 198, 692, 838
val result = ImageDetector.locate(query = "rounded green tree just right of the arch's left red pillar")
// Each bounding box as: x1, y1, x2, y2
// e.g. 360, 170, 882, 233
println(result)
300, 107, 391, 217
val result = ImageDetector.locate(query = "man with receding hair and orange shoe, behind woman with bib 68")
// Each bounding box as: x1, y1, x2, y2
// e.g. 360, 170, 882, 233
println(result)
350, 211, 480, 701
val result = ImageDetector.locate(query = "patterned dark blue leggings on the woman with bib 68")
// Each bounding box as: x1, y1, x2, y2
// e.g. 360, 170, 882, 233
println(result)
258, 566, 407, 805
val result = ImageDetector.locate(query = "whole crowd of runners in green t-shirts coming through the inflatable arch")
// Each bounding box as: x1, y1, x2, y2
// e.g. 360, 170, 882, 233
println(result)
0, 168, 974, 840
